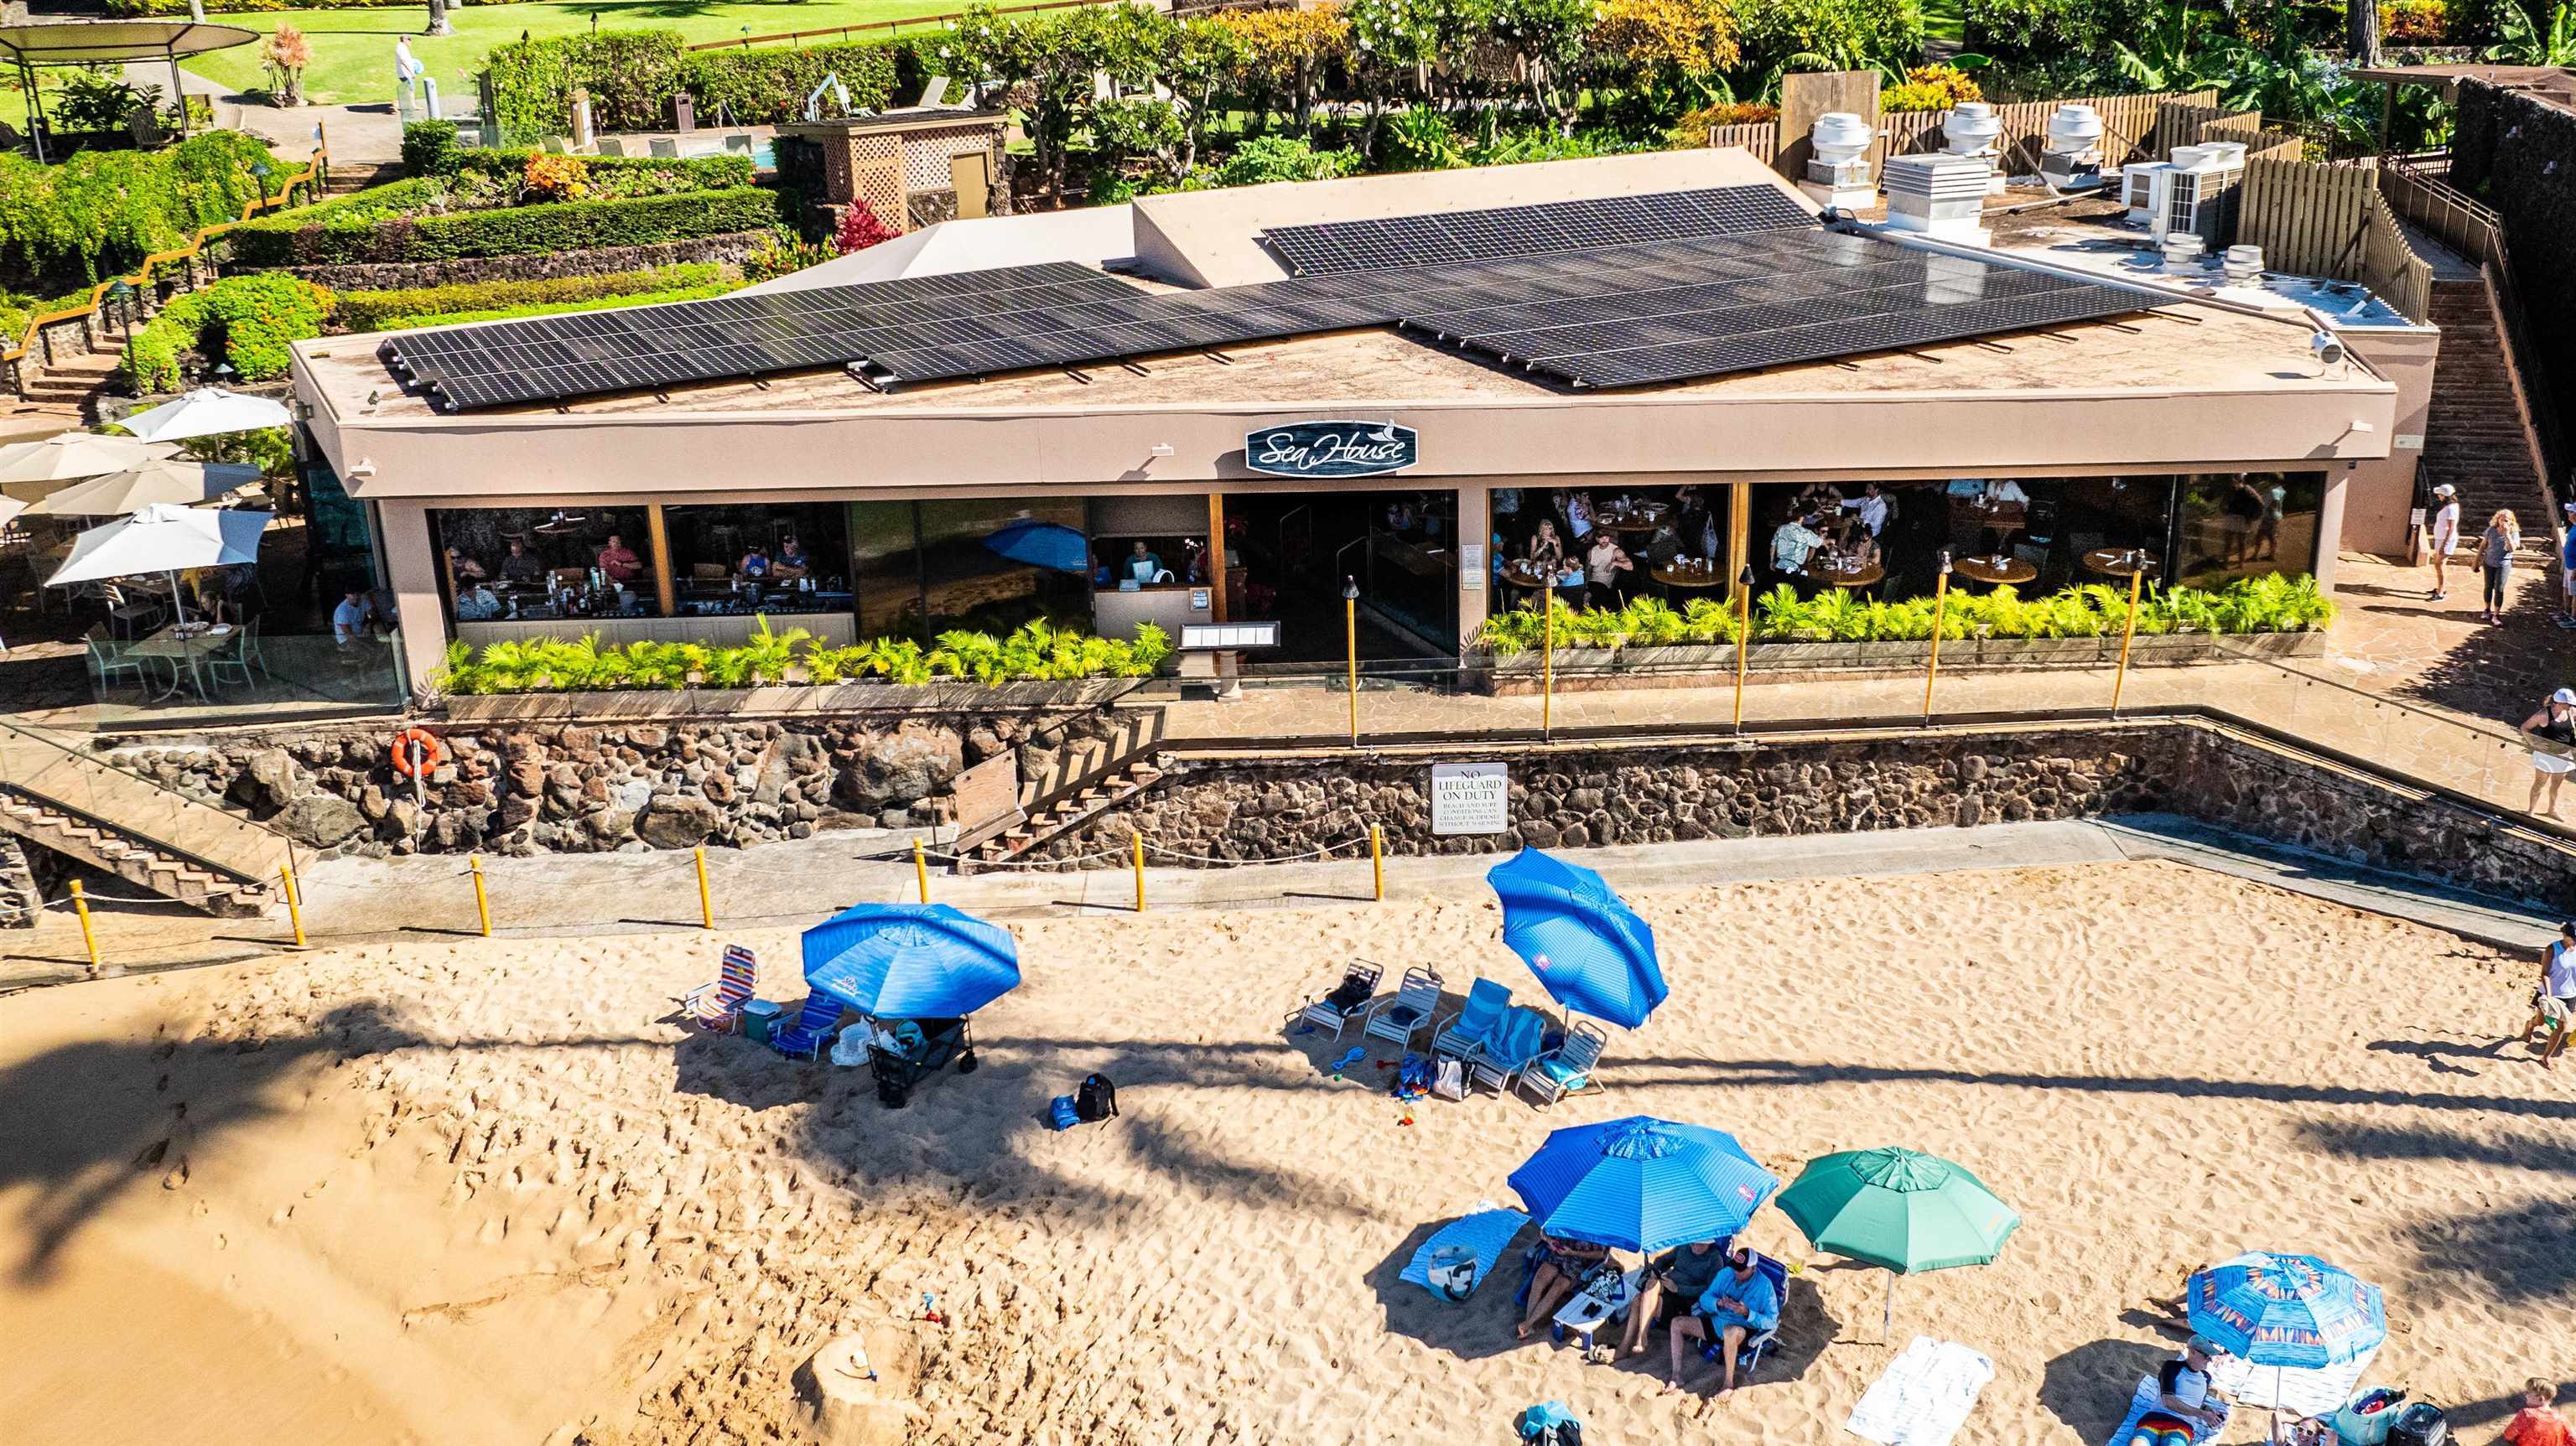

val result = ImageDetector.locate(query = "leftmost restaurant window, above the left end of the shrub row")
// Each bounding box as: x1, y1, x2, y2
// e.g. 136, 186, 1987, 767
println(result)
430, 507, 659, 623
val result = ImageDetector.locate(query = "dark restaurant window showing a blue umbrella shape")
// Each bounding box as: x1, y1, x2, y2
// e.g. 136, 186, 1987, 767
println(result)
848, 496, 1093, 640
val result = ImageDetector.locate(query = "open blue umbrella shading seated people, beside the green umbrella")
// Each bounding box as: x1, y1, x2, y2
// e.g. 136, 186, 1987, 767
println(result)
1512, 1114, 1780, 1253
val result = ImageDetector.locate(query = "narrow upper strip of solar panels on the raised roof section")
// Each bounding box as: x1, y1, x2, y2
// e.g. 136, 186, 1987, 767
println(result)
1262, 185, 1816, 275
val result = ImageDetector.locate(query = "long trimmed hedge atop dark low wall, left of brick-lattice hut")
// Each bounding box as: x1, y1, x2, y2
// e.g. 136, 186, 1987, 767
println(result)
226, 180, 778, 267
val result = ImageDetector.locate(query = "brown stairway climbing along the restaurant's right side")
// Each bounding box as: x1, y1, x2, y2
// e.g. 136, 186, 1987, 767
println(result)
2424, 272, 2550, 558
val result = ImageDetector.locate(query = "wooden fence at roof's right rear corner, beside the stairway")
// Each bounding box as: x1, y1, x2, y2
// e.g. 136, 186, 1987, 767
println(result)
2236, 157, 2432, 324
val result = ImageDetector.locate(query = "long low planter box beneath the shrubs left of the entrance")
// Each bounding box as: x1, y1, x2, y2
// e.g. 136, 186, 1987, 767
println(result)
445, 676, 1144, 723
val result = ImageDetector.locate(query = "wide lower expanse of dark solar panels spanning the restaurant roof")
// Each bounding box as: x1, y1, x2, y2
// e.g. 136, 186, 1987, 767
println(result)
382, 193, 2163, 409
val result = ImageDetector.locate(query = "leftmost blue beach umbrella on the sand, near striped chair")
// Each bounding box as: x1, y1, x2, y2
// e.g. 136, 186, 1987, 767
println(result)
803, 903, 1021, 1018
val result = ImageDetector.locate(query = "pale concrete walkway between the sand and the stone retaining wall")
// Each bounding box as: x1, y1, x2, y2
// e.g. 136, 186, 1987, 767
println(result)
0, 816, 2555, 991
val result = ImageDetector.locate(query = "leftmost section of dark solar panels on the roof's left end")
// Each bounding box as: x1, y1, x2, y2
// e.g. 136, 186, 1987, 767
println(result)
379, 262, 1144, 409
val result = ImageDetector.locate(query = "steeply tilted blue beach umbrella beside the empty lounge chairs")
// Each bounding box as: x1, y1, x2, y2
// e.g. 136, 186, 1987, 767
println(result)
1483, 849, 1672, 1029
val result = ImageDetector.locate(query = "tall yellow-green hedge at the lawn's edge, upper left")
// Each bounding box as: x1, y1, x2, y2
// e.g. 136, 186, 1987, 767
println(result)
485, 31, 920, 142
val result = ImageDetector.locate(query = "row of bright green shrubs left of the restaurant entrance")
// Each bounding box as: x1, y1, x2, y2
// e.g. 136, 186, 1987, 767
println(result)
435, 618, 1172, 695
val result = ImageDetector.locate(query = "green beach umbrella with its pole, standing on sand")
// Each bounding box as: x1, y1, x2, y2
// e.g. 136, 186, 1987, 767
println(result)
1773, 1148, 2023, 1338
